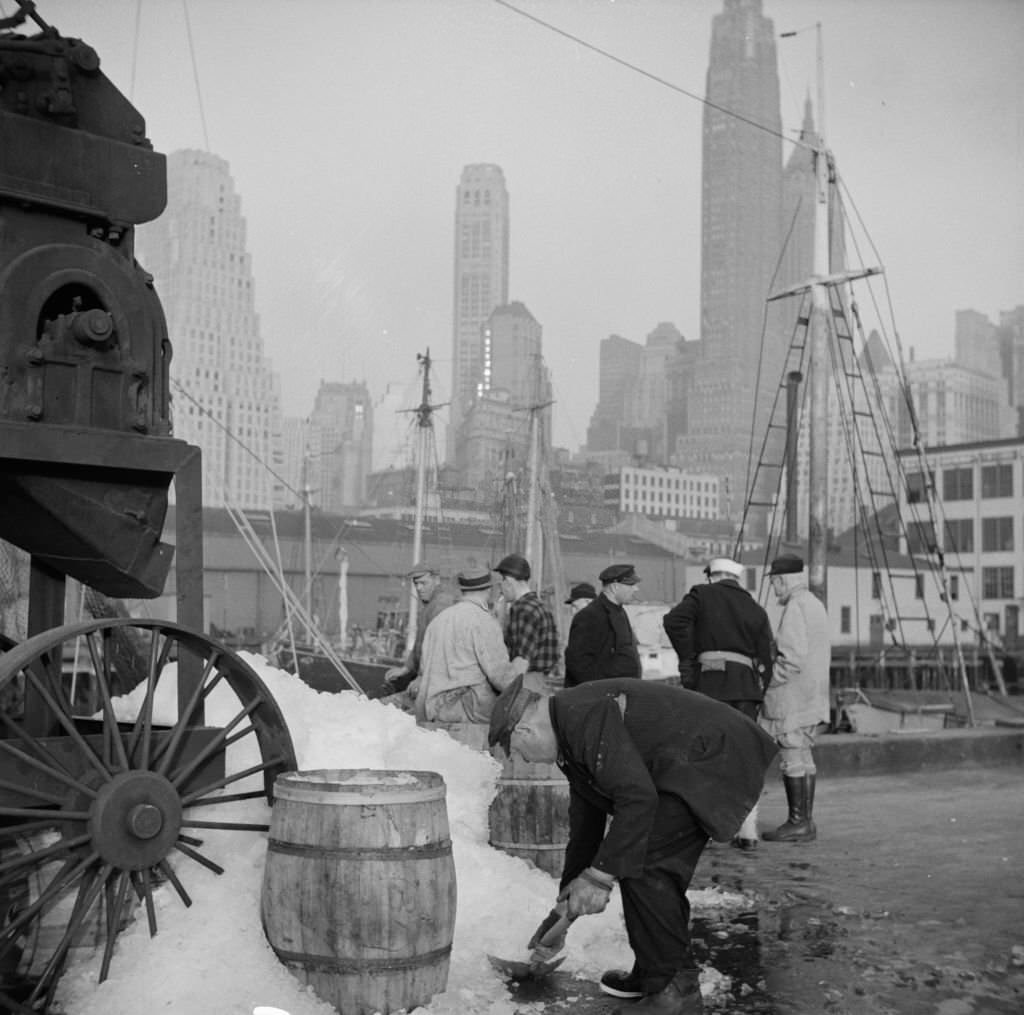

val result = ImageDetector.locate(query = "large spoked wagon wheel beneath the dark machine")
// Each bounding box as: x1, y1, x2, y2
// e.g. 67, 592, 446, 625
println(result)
0, 618, 296, 1012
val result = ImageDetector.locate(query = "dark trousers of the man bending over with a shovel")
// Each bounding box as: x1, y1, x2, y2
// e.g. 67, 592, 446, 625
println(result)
618, 796, 708, 993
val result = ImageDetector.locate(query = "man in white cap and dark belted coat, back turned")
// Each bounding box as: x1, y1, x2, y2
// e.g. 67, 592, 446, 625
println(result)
662, 557, 772, 850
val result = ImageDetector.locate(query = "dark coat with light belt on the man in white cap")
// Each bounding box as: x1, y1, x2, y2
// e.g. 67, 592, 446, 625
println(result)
662, 579, 772, 702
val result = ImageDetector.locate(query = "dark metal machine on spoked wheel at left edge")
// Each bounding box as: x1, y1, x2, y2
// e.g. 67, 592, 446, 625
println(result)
0, 0, 295, 1012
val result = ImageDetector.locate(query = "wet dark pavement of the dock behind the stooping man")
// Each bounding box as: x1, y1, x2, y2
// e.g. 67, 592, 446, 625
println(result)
503, 765, 1024, 1015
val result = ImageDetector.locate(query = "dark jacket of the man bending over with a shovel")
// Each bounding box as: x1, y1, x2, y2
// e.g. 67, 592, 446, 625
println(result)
549, 679, 778, 884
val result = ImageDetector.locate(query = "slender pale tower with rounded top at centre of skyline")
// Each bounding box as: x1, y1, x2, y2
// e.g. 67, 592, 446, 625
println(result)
447, 164, 509, 461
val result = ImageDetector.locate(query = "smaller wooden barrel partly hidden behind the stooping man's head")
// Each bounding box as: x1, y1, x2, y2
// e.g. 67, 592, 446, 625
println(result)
490, 751, 569, 878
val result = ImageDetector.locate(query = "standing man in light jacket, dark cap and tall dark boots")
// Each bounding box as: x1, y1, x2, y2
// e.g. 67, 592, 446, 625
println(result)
761, 553, 831, 842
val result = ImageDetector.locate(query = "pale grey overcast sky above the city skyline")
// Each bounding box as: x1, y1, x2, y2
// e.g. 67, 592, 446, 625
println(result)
25, 0, 1024, 466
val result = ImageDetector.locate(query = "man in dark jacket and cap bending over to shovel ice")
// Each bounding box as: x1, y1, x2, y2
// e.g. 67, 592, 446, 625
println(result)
489, 677, 777, 1015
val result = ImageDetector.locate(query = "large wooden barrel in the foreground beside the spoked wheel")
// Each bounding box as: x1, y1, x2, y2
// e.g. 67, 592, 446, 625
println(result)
262, 769, 456, 1015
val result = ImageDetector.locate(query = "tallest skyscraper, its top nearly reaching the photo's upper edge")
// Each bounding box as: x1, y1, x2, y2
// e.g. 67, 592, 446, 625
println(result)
677, 0, 782, 516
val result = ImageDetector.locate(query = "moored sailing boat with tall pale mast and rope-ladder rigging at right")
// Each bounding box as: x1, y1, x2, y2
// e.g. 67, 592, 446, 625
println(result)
735, 25, 1024, 732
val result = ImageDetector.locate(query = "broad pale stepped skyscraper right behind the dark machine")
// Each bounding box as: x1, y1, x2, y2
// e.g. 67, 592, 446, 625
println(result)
136, 150, 281, 509
